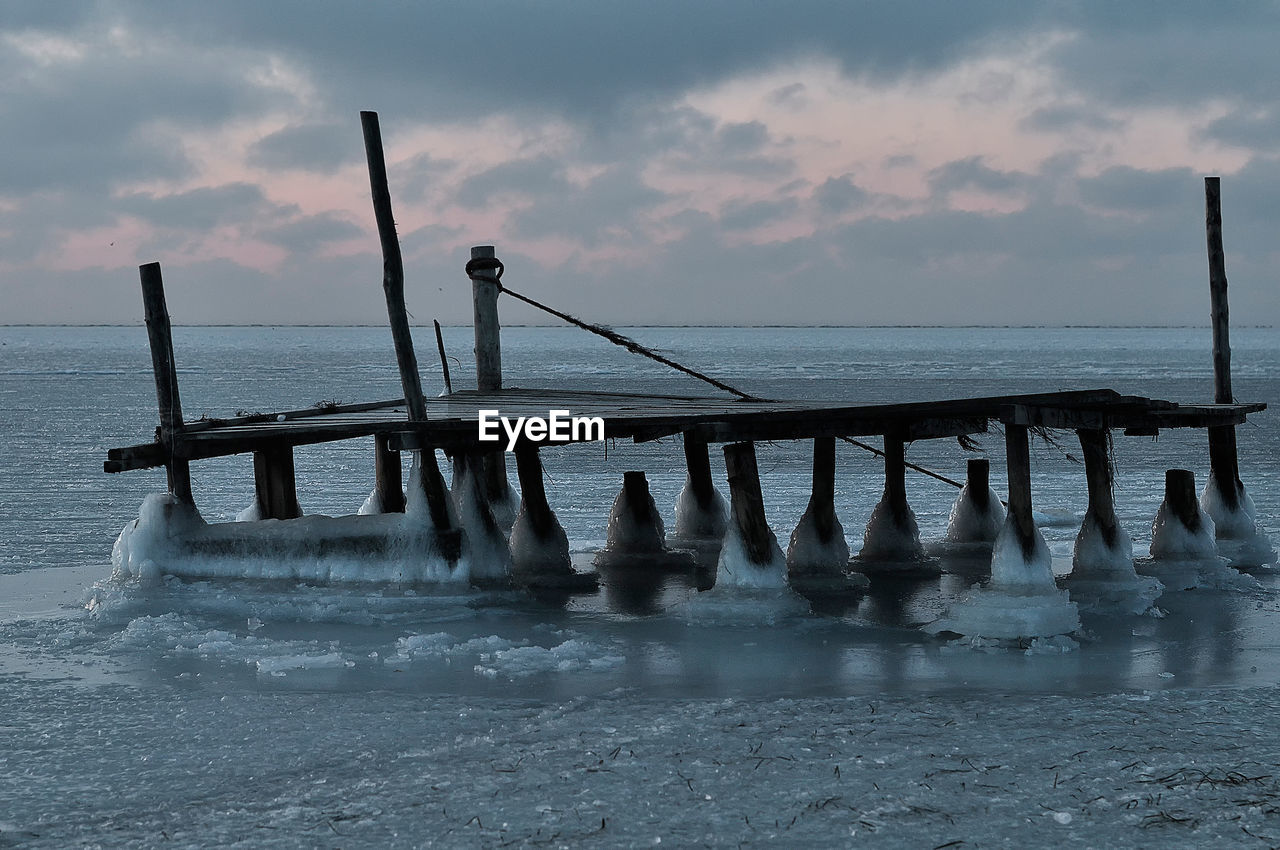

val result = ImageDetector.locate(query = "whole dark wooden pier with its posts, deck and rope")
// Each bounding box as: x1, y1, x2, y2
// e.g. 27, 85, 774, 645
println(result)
104, 113, 1266, 601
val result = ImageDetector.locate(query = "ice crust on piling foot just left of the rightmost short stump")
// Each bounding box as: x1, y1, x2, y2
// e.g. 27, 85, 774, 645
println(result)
1066, 512, 1165, 616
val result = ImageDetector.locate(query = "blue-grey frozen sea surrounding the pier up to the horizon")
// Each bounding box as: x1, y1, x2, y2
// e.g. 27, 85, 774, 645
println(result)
0, 322, 1280, 849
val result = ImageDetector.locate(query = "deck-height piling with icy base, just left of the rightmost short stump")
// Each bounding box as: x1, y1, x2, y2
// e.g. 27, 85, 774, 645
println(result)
1066, 429, 1164, 614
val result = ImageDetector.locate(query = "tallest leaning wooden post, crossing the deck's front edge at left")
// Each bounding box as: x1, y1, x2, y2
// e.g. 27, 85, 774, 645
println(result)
360, 111, 462, 561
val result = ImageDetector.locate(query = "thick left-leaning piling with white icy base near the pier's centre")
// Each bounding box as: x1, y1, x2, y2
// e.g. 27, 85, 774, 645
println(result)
716, 443, 786, 588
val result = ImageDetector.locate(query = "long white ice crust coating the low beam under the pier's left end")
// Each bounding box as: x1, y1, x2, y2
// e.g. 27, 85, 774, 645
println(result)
111, 493, 470, 584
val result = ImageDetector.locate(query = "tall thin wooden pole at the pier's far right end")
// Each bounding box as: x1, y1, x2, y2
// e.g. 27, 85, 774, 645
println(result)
1204, 177, 1242, 511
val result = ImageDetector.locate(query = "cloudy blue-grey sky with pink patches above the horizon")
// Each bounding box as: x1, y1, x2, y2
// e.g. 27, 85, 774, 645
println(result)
0, 0, 1280, 326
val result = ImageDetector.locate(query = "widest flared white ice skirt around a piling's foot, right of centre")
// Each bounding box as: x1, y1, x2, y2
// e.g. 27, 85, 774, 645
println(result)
924, 517, 1080, 640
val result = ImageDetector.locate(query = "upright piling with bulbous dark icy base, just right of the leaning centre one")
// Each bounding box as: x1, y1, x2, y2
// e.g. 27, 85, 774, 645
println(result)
787, 437, 868, 593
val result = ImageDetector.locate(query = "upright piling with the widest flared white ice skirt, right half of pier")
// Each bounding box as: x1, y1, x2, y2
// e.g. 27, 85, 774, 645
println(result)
925, 424, 1080, 640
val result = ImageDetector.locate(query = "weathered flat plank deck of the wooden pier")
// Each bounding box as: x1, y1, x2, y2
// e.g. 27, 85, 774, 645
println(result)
104, 388, 1266, 472
